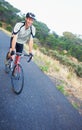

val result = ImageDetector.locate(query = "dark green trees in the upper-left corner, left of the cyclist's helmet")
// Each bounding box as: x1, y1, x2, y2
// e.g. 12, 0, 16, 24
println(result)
0, 0, 21, 26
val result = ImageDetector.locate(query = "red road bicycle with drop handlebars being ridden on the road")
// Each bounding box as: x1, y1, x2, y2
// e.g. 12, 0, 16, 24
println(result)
5, 52, 32, 94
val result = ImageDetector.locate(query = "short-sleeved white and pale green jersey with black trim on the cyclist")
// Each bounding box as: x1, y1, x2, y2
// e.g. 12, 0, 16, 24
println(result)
13, 22, 35, 44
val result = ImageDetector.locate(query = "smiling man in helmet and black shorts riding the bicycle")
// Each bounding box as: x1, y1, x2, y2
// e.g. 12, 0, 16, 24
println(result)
6, 12, 36, 60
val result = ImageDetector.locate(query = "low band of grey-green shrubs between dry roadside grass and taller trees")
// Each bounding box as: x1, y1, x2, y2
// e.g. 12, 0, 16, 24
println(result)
40, 47, 82, 77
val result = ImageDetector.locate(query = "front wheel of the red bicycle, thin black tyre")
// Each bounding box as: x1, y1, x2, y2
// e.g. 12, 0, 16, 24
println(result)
11, 64, 24, 94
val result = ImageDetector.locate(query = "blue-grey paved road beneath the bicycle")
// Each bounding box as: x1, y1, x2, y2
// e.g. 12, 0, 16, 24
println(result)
0, 31, 82, 130
